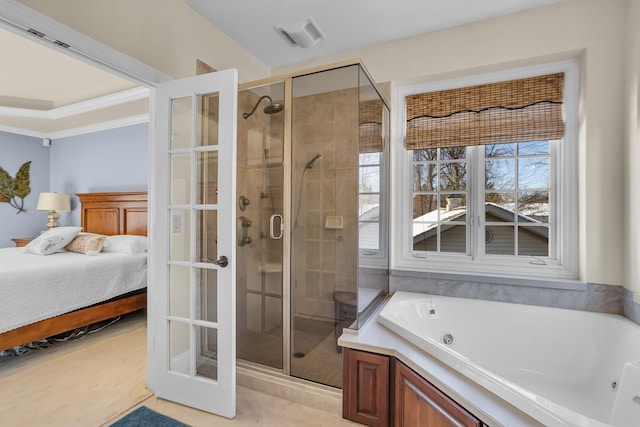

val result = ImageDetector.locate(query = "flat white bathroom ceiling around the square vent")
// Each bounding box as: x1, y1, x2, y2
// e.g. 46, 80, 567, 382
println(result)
184, 0, 561, 67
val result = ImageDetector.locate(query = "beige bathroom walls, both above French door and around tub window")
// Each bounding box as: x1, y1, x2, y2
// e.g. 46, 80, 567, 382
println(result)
21, 0, 640, 290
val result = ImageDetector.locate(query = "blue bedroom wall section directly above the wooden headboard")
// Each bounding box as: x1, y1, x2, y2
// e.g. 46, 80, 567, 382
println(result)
51, 123, 149, 225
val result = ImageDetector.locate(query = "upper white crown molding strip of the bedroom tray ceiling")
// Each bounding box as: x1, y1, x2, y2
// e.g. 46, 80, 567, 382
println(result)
0, 87, 149, 120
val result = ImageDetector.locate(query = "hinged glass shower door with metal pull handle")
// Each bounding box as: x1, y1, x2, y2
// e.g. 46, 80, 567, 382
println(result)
237, 83, 284, 369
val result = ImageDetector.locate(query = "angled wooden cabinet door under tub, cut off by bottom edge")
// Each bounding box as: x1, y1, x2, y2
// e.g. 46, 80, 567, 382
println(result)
393, 360, 482, 427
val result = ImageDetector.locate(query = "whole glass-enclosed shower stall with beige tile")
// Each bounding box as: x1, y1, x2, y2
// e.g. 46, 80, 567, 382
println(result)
236, 63, 389, 387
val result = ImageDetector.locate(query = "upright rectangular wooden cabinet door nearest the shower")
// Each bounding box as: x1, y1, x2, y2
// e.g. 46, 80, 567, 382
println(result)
342, 348, 390, 427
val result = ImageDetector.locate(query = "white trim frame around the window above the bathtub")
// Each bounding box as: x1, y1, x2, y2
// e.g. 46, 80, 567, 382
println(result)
390, 60, 579, 281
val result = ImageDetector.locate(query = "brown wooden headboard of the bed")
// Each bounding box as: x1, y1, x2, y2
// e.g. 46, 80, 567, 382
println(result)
76, 191, 147, 236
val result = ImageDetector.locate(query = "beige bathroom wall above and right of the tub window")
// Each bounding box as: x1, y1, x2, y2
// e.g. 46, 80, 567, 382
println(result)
273, 0, 640, 287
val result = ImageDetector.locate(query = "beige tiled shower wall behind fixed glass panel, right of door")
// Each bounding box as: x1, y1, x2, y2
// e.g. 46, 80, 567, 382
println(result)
292, 89, 358, 319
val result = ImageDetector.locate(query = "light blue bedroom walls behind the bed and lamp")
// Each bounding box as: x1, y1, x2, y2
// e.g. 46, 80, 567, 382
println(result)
0, 123, 149, 247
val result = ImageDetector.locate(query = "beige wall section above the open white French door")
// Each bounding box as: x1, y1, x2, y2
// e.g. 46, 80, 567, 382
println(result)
19, 0, 270, 82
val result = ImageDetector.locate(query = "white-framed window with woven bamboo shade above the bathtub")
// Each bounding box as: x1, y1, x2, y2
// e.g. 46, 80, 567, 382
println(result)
392, 62, 578, 279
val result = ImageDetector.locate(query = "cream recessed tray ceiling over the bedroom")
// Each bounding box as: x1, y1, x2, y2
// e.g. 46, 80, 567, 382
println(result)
0, 28, 149, 136
